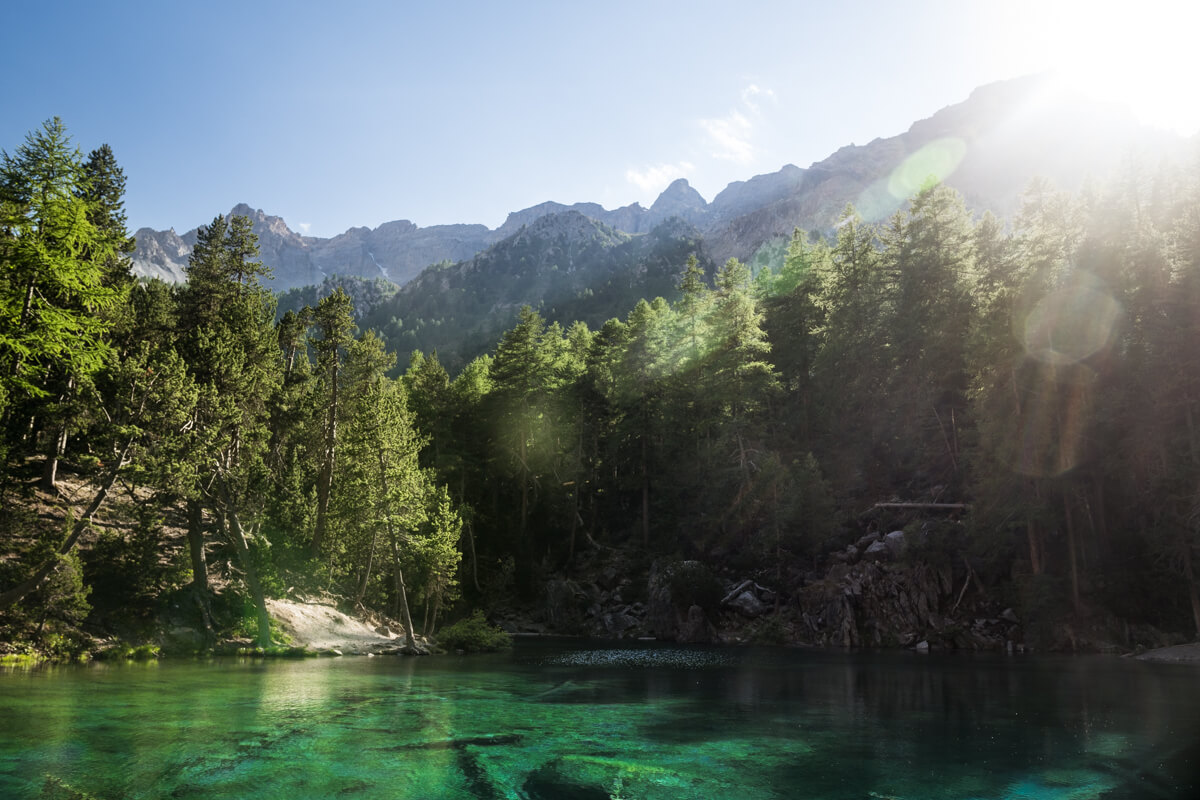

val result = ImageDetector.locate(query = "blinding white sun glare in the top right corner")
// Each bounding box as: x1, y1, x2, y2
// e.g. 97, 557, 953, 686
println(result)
1006, 0, 1200, 136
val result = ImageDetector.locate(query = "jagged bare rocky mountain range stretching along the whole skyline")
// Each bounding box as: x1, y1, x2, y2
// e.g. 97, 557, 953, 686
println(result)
133, 77, 1183, 293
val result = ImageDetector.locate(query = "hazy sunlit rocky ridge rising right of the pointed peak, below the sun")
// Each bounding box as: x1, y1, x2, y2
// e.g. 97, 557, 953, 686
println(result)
703, 77, 1182, 261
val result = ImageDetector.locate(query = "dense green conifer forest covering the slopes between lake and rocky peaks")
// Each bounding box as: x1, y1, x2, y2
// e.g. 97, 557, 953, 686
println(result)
0, 120, 1200, 654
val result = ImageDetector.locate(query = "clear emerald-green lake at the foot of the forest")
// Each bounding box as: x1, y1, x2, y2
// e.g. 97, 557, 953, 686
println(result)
0, 639, 1200, 800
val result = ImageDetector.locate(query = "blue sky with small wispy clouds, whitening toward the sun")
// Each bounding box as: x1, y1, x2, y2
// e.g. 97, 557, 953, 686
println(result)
0, 0, 1200, 236
